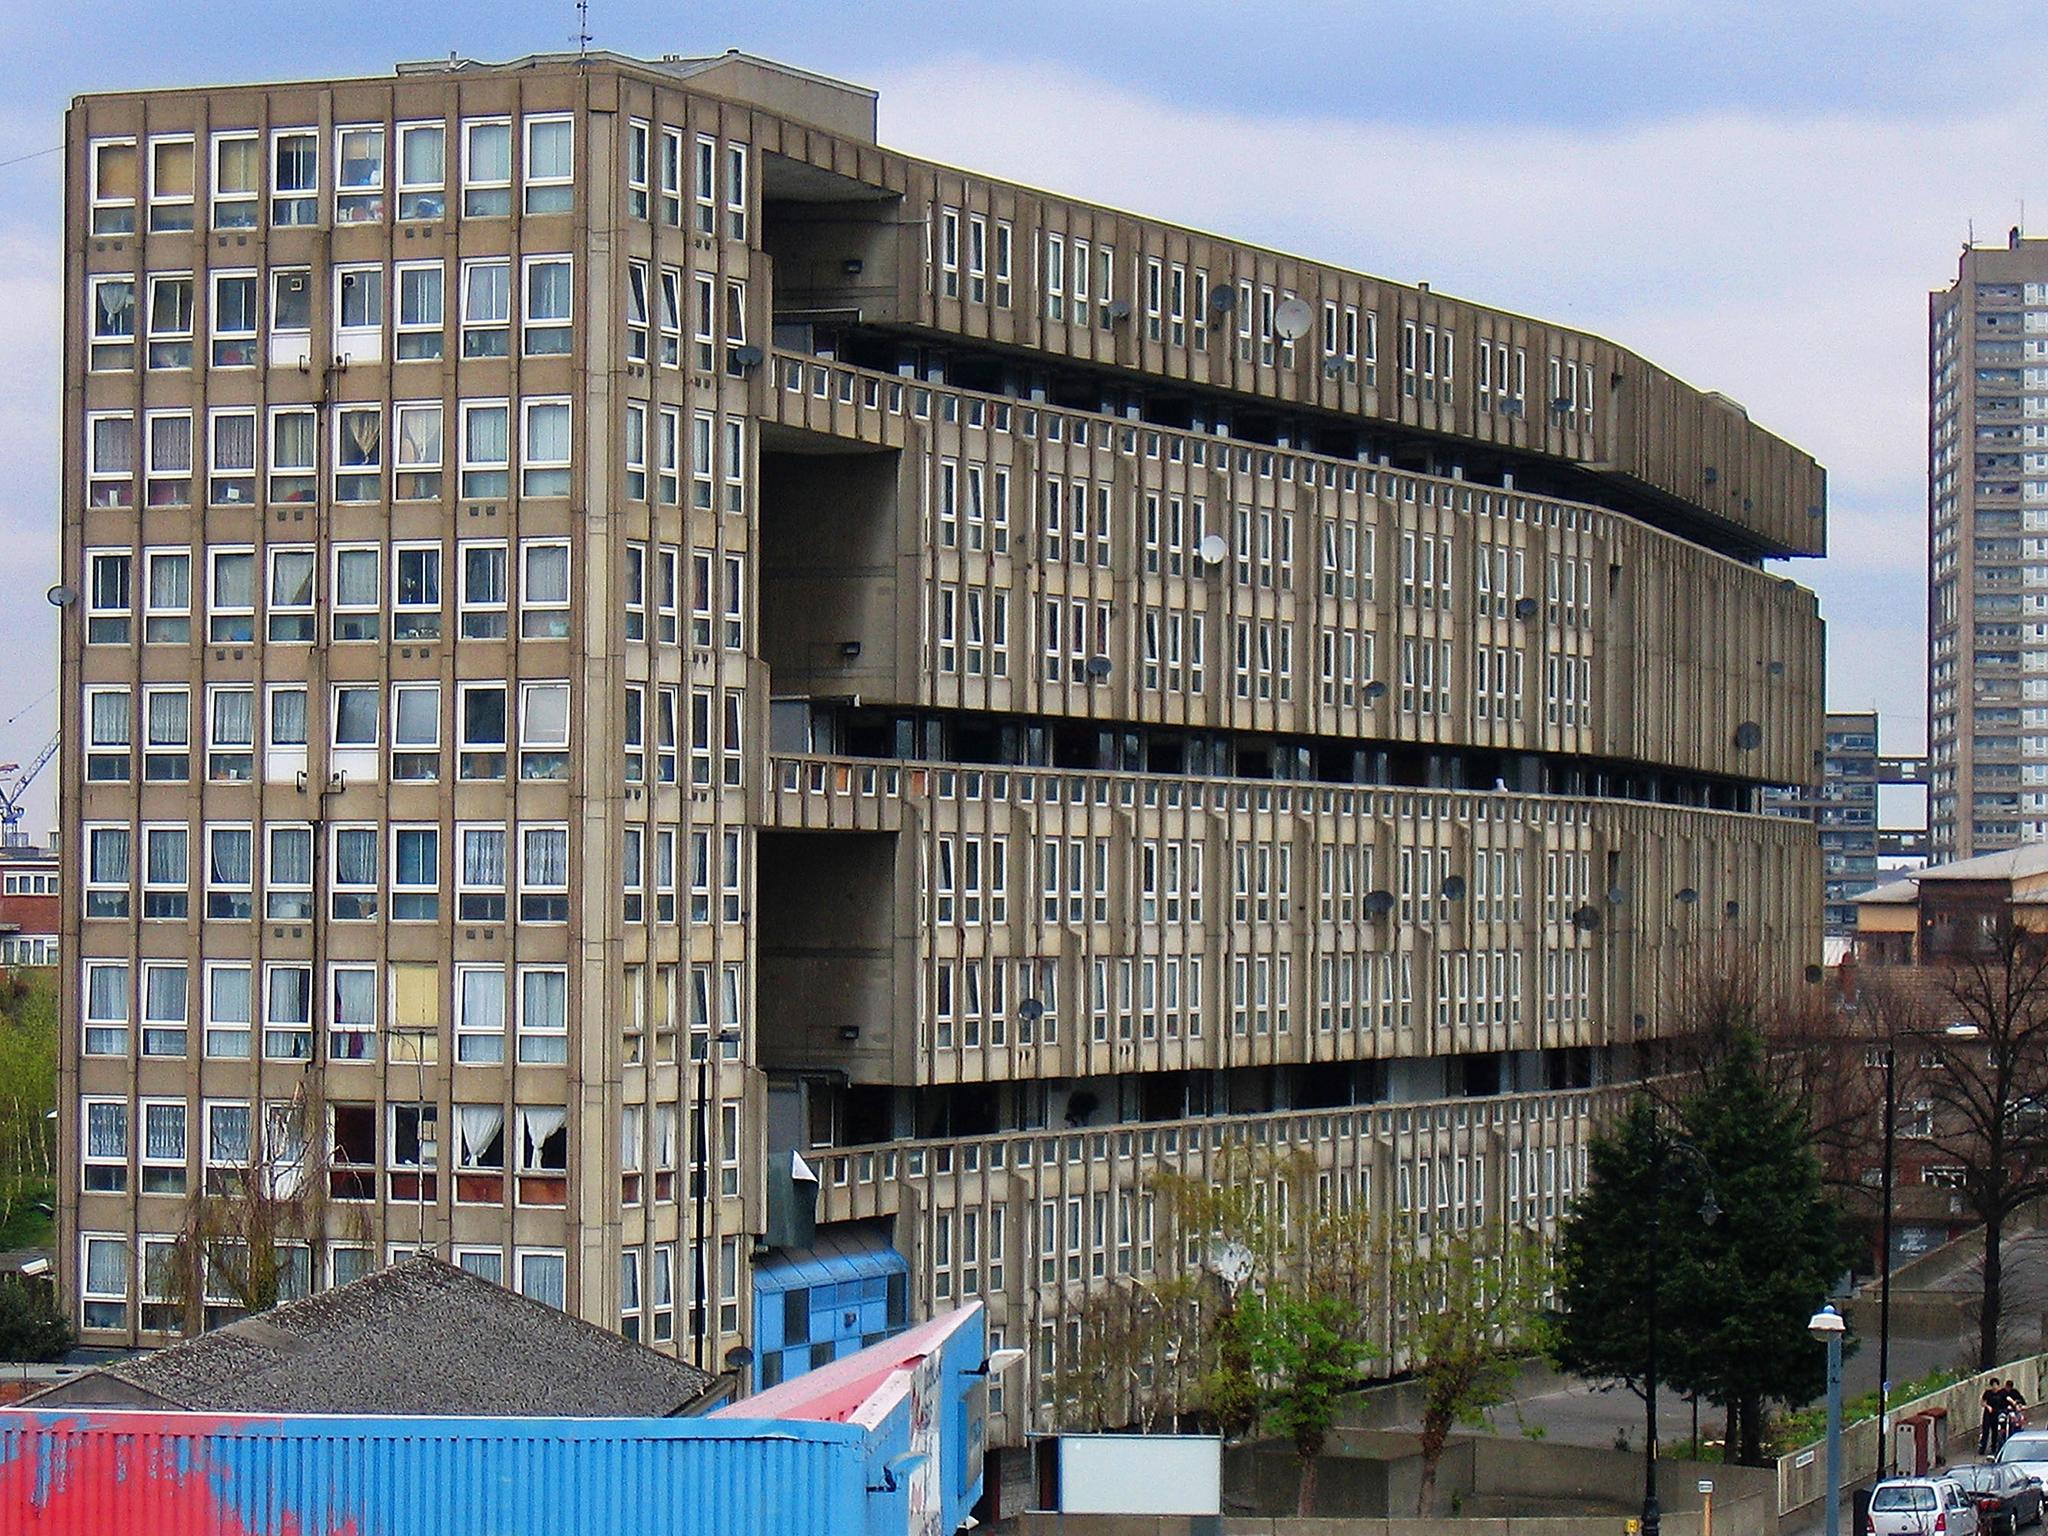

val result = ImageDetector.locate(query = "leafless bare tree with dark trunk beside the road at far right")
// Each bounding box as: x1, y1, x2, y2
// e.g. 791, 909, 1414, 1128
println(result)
1882, 920, 2048, 1370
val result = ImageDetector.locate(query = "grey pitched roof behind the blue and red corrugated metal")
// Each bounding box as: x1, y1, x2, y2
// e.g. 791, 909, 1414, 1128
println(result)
39, 1255, 713, 1417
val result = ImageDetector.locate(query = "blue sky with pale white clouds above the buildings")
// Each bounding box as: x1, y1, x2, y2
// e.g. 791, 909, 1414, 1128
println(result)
0, 0, 2048, 825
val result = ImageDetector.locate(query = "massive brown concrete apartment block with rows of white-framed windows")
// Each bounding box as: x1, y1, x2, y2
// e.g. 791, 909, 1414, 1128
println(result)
61, 53, 1825, 1444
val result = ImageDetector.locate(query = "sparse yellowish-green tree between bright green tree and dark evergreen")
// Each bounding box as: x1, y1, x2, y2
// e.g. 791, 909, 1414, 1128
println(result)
1400, 1229, 1546, 1518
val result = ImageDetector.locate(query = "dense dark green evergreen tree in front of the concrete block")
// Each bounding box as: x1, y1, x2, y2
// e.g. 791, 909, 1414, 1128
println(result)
1552, 1030, 1849, 1462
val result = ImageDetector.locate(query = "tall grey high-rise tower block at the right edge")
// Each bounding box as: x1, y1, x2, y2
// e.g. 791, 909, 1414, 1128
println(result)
1927, 240, 2048, 862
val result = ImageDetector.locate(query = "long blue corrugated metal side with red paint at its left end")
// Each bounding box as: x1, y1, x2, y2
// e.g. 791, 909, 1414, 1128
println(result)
0, 1409, 892, 1536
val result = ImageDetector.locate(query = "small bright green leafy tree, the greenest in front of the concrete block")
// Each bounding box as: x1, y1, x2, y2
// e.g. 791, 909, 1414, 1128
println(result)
1233, 1288, 1370, 1516
